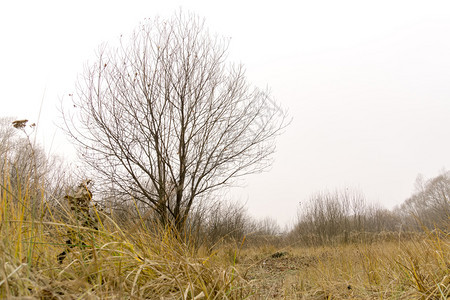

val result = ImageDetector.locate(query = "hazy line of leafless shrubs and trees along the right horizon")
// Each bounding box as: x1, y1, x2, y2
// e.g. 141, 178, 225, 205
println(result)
288, 172, 450, 244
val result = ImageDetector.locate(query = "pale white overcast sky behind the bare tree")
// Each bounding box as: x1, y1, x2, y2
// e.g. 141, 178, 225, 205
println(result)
0, 0, 450, 224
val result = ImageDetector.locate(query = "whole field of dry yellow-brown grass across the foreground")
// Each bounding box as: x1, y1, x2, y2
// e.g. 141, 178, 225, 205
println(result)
0, 179, 450, 299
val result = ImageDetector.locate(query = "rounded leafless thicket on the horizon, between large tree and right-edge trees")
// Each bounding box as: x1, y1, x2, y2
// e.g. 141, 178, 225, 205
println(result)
288, 189, 400, 245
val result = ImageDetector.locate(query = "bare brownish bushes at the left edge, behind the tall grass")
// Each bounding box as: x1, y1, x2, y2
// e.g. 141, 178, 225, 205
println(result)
0, 117, 74, 213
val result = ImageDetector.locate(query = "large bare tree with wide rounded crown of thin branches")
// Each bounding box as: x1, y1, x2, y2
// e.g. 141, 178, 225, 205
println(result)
63, 13, 287, 228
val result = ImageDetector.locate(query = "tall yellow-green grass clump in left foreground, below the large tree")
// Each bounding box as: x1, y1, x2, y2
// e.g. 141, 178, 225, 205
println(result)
0, 176, 248, 299
